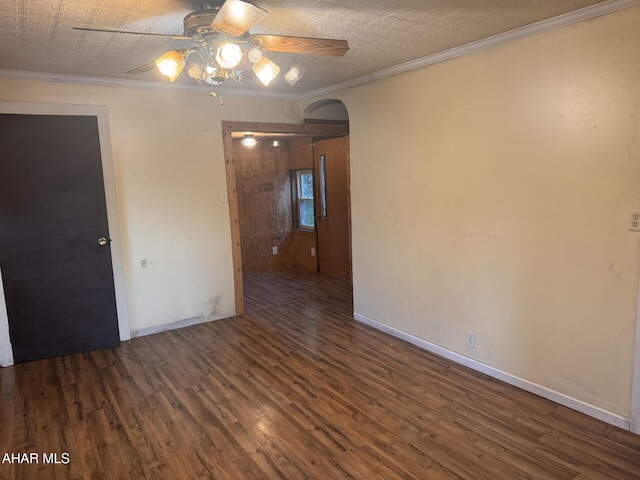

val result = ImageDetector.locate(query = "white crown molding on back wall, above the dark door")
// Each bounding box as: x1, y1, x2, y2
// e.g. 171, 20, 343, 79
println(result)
0, 69, 301, 100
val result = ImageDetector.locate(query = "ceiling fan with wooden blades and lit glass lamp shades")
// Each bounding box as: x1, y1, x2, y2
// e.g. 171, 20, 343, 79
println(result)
74, 0, 349, 86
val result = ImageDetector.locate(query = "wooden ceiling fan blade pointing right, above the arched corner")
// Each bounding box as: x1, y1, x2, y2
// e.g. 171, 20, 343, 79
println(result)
249, 35, 349, 57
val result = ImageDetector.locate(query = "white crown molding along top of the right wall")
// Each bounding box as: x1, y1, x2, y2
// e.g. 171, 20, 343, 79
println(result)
302, 0, 640, 101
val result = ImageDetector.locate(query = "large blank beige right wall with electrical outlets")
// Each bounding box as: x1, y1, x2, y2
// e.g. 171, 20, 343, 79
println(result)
308, 7, 640, 419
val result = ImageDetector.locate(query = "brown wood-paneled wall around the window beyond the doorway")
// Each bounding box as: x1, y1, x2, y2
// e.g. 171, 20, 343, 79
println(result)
233, 138, 317, 274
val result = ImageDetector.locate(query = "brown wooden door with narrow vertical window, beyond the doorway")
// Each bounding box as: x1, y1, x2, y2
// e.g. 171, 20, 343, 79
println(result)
314, 137, 351, 280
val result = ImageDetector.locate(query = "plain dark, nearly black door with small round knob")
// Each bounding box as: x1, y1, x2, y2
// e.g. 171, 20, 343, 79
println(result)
0, 114, 120, 363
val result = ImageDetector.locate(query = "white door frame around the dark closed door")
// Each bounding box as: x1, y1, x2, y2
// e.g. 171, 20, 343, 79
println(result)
0, 102, 131, 367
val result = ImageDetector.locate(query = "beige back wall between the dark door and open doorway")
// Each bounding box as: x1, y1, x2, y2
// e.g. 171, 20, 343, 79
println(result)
0, 79, 300, 334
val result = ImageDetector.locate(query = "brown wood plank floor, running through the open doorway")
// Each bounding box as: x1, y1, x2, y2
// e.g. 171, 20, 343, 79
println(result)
0, 272, 640, 480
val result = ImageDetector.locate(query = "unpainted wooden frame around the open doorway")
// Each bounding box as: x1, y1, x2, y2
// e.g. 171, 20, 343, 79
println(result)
222, 121, 349, 315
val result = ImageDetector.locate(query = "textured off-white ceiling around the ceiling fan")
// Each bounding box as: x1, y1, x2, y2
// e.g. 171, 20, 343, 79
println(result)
0, 0, 620, 93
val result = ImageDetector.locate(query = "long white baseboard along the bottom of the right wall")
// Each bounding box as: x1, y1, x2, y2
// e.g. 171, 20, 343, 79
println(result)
353, 313, 631, 430
